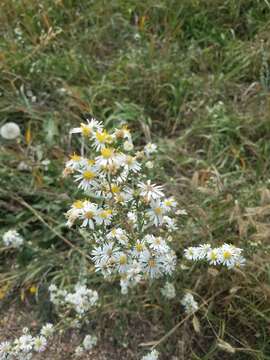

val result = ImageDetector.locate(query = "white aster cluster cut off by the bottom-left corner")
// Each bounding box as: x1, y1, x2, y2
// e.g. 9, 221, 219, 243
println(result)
0, 324, 54, 360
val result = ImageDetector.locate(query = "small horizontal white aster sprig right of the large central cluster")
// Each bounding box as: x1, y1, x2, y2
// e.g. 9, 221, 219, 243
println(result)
184, 244, 245, 269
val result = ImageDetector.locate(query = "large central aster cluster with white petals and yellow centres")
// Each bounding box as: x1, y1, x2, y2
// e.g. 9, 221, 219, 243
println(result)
64, 119, 183, 294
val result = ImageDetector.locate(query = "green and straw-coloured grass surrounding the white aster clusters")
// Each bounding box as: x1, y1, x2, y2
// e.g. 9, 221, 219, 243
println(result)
0, 0, 270, 360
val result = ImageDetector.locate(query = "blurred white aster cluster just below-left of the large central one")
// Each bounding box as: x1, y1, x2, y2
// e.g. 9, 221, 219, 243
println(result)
49, 284, 98, 318
